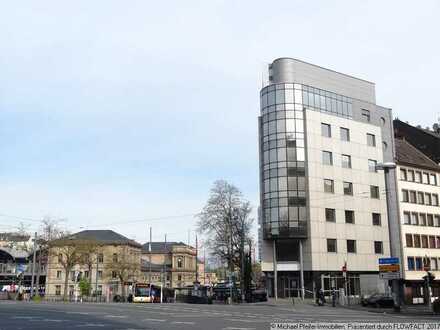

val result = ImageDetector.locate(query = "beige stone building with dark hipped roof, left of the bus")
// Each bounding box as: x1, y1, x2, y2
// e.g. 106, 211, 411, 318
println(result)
46, 230, 142, 300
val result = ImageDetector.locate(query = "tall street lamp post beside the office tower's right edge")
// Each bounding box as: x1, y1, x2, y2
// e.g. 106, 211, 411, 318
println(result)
376, 162, 402, 312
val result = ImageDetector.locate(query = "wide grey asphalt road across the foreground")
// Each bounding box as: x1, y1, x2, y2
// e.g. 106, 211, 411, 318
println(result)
0, 301, 439, 330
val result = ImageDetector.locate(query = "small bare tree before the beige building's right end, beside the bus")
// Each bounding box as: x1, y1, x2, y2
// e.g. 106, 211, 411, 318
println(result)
104, 245, 141, 299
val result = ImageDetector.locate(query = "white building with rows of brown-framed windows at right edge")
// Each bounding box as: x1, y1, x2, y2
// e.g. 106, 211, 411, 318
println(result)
395, 139, 440, 304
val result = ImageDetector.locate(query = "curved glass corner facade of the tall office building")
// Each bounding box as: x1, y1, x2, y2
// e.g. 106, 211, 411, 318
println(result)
260, 84, 307, 238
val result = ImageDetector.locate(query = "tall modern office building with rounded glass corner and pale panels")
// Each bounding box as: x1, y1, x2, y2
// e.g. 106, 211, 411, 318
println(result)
258, 58, 401, 297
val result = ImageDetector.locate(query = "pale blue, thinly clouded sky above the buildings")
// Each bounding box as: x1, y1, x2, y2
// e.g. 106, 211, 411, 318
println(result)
0, 0, 440, 246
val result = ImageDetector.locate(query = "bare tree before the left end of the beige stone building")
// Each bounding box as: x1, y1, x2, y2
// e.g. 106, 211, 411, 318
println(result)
49, 237, 98, 300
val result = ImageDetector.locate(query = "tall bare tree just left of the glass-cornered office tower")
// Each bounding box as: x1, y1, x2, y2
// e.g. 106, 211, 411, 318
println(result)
197, 180, 253, 296
